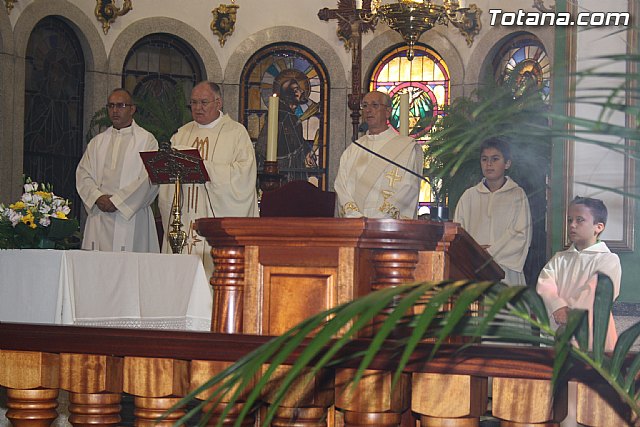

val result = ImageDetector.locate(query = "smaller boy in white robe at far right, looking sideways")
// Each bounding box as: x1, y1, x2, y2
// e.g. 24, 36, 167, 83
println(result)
536, 197, 622, 351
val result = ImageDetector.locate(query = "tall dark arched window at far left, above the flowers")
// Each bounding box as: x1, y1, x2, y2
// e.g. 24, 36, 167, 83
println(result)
23, 16, 85, 217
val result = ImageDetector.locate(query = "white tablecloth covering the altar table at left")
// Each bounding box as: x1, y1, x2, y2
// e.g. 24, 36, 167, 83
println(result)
0, 249, 212, 331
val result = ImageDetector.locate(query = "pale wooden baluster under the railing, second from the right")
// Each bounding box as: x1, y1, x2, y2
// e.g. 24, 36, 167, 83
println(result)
491, 377, 567, 427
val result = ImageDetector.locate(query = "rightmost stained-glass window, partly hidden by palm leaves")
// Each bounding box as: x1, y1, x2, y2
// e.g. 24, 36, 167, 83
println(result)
493, 34, 551, 102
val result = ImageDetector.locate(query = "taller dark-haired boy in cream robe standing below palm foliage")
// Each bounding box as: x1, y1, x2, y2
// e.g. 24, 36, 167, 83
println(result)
453, 138, 531, 285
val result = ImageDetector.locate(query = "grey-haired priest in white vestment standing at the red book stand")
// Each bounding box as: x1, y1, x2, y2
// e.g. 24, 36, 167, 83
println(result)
159, 82, 258, 277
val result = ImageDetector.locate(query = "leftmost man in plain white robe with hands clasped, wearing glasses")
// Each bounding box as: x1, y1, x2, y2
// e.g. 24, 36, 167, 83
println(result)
76, 89, 160, 252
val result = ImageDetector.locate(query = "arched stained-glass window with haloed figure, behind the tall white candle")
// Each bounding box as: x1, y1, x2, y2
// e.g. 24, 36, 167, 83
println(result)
240, 43, 329, 188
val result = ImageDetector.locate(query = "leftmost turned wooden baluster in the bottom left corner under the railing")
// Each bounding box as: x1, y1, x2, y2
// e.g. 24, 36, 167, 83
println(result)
0, 350, 59, 427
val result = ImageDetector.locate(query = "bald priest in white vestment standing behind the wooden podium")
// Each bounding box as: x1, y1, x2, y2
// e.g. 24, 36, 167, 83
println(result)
334, 91, 424, 219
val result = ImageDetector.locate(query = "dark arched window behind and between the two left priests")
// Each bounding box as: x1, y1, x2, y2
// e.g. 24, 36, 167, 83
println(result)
122, 33, 204, 142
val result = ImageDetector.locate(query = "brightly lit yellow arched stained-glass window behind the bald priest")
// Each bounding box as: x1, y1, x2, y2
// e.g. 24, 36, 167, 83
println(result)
369, 45, 451, 205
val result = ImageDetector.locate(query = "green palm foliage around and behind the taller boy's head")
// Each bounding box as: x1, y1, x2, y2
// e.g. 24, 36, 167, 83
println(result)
425, 85, 551, 207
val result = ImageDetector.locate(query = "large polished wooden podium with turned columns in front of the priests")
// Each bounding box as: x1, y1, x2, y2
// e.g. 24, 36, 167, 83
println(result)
195, 217, 504, 335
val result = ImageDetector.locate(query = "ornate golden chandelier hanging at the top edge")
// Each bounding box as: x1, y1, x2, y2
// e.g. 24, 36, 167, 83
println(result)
355, 0, 482, 60
